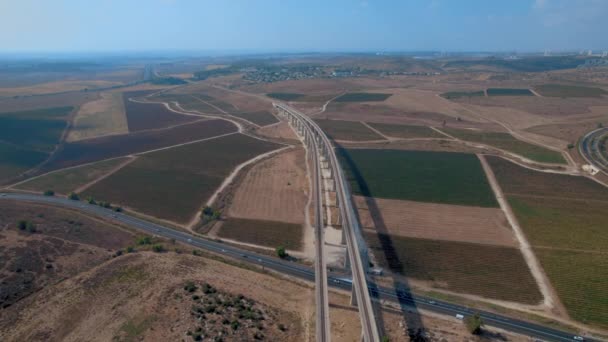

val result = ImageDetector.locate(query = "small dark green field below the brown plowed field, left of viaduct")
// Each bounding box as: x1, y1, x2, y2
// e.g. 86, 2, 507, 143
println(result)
218, 218, 303, 250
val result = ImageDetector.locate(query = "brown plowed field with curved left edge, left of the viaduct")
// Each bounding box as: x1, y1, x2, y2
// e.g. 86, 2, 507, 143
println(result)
230, 148, 308, 223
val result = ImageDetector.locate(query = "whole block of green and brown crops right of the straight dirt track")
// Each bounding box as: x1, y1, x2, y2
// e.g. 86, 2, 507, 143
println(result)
487, 157, 608, 327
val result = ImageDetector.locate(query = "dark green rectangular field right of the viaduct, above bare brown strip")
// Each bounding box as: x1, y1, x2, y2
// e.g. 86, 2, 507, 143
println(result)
339, 149, 498, 207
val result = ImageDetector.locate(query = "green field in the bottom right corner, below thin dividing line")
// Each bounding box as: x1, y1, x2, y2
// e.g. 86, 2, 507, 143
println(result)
534, 248, 608, 328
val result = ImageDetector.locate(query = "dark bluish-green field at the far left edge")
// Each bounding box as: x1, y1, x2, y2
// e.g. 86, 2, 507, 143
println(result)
0, 107, 73, 183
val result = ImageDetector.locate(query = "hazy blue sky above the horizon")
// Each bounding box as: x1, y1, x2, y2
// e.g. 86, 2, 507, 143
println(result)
0, 0, 608, 53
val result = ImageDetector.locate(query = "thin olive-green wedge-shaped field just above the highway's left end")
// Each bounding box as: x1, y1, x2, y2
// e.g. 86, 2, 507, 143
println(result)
16, 158, 127, 194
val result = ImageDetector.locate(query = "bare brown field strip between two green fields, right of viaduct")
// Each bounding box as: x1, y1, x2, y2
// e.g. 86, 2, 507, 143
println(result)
355, 196, 517, 247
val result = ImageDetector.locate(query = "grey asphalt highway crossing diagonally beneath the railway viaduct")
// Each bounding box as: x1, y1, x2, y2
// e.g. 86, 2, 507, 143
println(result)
0, 193, 595, 341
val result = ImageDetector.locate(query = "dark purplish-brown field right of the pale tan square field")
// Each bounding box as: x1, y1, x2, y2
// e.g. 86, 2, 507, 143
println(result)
123, 93, 196, 132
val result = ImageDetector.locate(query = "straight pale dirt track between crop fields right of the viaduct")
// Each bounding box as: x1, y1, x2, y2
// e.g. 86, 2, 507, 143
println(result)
477, 154, 567, 316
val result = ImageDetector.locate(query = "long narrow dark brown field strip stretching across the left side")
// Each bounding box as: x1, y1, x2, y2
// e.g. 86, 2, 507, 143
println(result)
41, 120, 237, 172
